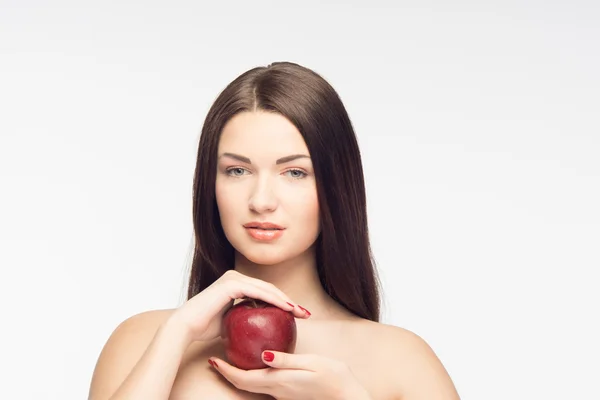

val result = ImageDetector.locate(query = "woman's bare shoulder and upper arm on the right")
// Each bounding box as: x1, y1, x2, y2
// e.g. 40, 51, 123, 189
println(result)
364, 321, 460, 400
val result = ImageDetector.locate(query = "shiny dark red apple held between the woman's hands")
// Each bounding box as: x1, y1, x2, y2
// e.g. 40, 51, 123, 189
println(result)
222, 299, 296, 370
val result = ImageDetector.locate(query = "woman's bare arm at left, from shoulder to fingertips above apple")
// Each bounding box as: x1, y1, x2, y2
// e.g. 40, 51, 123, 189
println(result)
89, 270, 310, 400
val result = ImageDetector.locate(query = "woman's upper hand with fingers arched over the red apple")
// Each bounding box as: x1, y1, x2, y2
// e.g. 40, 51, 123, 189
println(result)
171, 270, 310, 341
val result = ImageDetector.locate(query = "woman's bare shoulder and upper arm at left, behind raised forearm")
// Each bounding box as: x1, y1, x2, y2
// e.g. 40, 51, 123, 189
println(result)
89, 309, 174, 399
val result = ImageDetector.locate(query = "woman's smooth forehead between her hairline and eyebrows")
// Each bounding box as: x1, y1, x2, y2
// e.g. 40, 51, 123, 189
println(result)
219, 111, 308, 157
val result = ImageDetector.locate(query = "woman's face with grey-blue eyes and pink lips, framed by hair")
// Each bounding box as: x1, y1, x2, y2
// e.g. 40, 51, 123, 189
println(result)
216, 111, 320, 265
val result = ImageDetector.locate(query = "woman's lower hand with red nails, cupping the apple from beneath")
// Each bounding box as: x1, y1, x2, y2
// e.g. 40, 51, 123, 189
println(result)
208, 351, 371, 400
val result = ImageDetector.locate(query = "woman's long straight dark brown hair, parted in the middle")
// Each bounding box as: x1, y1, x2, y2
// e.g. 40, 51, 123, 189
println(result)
187, 62, 380, 321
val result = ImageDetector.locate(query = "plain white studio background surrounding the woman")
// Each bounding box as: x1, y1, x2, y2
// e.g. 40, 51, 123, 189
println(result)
0, 0, 600, 400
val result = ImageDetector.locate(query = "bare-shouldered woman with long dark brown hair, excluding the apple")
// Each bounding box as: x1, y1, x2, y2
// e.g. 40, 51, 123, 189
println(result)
90, 63, 458, 400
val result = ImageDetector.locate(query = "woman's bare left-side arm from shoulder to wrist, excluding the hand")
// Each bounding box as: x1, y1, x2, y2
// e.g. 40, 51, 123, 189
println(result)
89, 311, 190, 400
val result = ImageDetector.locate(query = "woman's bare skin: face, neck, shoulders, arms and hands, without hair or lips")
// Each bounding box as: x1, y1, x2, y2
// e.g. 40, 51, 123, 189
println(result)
89, 111, 459, 400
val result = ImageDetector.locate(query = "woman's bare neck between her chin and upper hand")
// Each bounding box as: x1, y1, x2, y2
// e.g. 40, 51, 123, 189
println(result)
235, 250, 352, 320
